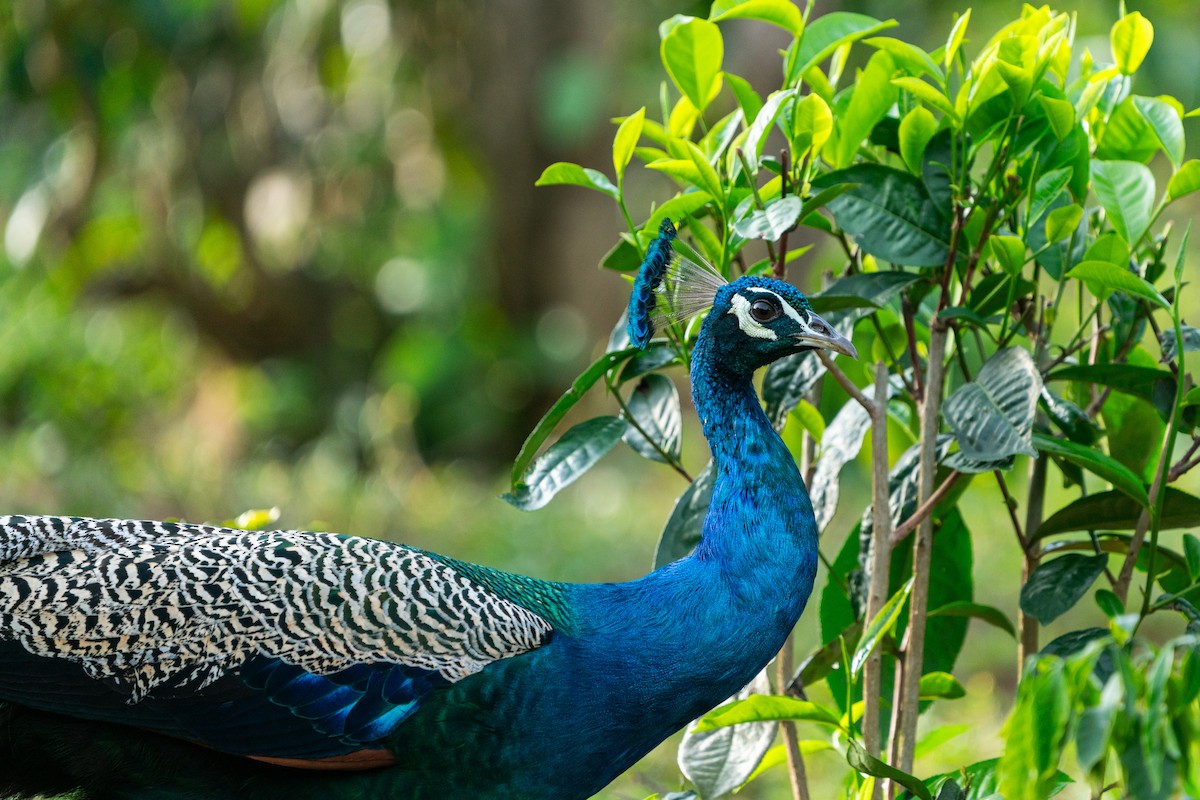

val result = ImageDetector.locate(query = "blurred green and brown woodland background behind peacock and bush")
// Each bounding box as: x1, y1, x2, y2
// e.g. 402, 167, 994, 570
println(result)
0, 0, 1200, 798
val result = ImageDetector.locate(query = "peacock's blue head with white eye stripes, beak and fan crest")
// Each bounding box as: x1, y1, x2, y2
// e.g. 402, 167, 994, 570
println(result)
629, 221, 858, 374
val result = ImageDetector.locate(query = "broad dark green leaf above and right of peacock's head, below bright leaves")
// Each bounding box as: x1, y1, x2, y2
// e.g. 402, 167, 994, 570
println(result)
812, 164, 950, 266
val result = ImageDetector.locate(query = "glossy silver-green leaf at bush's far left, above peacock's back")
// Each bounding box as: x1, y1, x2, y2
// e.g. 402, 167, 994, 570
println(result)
502, 416, 629, 511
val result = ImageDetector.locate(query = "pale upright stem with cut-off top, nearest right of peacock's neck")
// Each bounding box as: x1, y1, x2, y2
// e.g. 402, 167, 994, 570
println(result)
863, 361, 892, 800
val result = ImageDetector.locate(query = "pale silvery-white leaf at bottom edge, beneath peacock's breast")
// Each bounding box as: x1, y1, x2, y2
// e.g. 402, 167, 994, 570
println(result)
679, 673, 779, 798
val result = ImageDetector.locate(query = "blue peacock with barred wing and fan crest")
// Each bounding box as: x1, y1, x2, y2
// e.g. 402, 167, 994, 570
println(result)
0, 222, 856, 800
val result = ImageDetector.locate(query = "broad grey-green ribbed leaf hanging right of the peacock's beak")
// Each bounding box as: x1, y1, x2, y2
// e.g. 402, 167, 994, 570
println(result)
942, 347, 1042, 461
